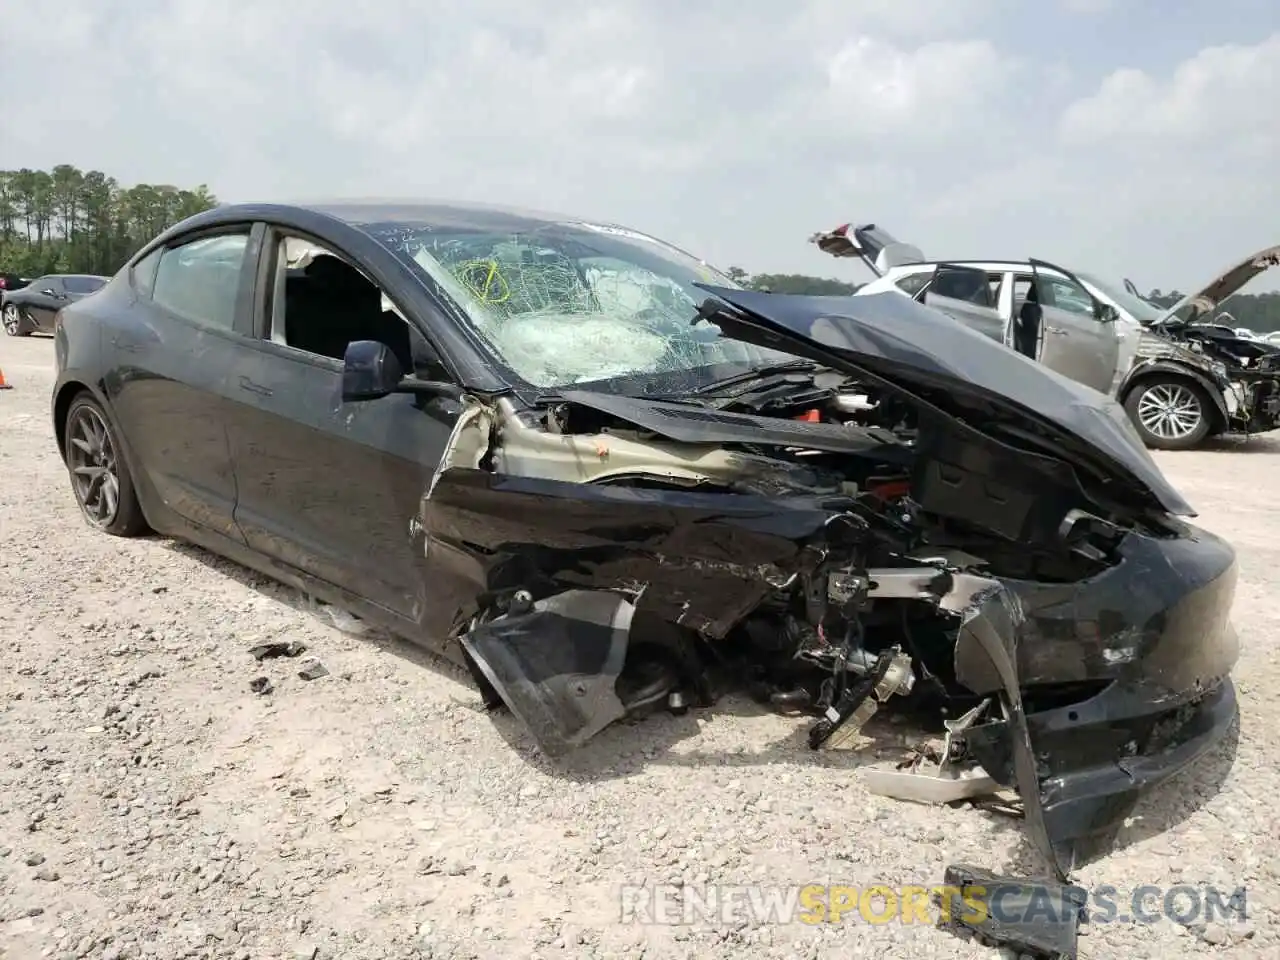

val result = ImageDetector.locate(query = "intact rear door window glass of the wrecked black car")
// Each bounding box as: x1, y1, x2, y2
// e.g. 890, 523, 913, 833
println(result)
151, 233, 248, 330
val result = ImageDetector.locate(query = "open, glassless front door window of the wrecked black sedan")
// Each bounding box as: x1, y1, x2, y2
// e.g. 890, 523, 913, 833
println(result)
268, 237, 424, 380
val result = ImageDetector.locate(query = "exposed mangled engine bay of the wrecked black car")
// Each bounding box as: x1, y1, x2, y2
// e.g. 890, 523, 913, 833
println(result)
448, 371, 1117, 753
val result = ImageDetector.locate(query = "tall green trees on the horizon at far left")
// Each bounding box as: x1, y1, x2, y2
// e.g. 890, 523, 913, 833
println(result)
0, 164, 218, 276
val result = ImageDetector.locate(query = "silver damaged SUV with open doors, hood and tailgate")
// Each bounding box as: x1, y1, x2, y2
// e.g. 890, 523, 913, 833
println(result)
810, 224, 1280, 449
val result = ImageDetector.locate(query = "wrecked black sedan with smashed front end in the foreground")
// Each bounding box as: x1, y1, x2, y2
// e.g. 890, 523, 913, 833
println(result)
52, 204, 1238, 931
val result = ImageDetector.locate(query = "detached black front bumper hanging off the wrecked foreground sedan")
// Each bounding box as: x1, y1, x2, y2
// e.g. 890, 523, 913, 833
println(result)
956, 527, 1239, 879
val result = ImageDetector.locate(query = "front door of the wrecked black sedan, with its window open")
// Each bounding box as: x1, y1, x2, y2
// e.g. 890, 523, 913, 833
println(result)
228, 233, 458, 623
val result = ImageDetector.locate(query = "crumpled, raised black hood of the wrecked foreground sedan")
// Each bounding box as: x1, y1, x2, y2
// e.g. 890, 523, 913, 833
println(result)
698, 284, 1196, 517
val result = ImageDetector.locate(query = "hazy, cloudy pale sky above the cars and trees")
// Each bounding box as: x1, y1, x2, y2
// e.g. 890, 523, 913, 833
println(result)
0, 0, 1280, 289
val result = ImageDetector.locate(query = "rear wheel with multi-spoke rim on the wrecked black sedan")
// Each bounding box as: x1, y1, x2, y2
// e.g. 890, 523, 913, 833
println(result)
63, 390, 147, 536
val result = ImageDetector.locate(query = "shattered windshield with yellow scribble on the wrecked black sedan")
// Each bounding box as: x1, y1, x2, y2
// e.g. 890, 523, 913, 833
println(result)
363, 221, 791, 389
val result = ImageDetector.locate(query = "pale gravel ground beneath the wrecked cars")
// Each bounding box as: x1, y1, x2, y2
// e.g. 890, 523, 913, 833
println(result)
0, 338, 1280, 960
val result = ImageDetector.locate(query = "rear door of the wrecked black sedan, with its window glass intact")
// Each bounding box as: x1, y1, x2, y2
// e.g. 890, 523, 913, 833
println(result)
102, 224, 262, 543
